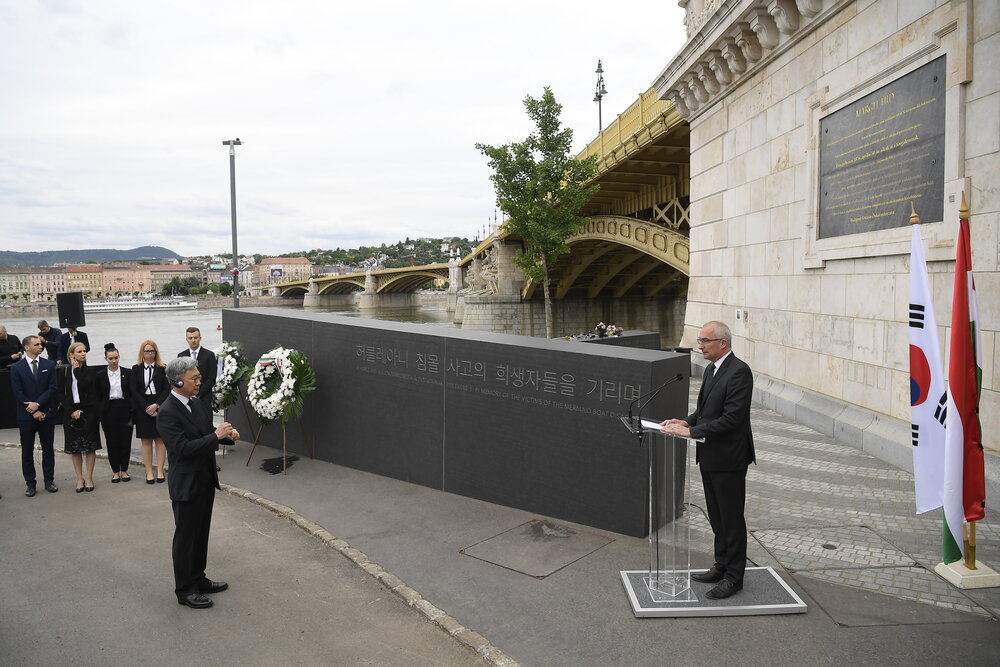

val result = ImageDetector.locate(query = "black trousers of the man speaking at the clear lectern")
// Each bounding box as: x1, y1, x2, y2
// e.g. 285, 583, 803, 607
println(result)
701, 468, 747, 584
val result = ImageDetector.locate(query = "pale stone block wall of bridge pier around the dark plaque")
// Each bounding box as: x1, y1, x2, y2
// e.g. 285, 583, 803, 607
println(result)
657, 0, 1000, 460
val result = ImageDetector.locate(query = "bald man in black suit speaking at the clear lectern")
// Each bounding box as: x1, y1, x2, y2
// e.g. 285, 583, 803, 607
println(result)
660, 322, 756, 599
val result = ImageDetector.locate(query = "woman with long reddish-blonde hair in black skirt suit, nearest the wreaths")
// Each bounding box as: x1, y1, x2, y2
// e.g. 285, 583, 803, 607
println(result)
129, 340, 170, 484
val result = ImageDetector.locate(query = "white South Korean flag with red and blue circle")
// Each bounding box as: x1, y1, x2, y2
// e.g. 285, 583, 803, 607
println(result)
910, 224, 948, 514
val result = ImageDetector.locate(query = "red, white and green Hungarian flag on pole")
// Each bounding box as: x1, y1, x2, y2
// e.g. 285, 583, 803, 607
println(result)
944, 214, 986, 563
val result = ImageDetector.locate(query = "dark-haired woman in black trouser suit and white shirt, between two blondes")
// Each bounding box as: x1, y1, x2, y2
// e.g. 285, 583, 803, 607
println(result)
95, 343, 132, 484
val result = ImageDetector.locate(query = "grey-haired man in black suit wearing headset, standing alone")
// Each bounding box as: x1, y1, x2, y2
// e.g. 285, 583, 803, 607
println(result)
156, 357, 240, 609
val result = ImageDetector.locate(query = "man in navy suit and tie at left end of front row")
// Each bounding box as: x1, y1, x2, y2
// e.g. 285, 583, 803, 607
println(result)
10, 336, 59, 498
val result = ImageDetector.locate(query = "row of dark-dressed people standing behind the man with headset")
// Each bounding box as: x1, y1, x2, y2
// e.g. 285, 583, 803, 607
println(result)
0, 320, 217, 497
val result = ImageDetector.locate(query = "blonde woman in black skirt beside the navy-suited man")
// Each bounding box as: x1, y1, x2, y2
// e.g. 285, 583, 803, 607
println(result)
62, 343, 101, 493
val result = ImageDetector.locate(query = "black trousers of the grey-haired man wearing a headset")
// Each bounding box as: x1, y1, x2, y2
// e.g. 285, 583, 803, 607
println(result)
172, 485, 215, 598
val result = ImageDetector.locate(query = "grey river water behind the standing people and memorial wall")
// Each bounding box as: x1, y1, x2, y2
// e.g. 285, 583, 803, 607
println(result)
0, 304, 453, 366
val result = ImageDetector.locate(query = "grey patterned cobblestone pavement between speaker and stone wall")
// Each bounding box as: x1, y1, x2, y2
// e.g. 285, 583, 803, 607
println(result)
688, 396, 1000, 617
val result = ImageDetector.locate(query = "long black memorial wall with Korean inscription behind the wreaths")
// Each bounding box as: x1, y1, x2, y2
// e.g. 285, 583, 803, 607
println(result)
223, 308, 690, 536
